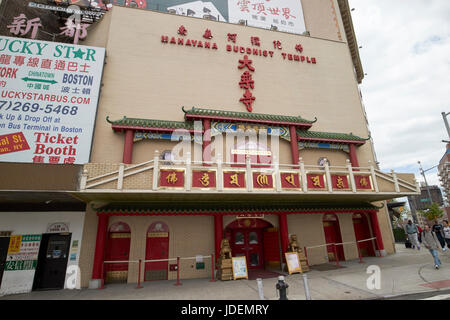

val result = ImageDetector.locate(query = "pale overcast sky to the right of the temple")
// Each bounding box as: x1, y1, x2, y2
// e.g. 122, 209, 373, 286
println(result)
349, 0, 450, 199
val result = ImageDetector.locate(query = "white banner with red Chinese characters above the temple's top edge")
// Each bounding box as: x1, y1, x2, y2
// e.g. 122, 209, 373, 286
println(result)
228, 0, 306, 34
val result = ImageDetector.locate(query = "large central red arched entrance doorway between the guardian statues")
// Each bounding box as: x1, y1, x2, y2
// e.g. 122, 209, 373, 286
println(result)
225, 218, 280, 270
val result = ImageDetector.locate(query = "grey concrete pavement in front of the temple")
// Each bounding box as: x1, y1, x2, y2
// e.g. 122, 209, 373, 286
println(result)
0, 244, 450, 300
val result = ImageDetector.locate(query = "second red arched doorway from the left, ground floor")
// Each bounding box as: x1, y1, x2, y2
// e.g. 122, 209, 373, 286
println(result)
144, 221, 169, 281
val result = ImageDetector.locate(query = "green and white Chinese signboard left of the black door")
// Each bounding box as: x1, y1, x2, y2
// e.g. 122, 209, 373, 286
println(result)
5, 235, 41, 271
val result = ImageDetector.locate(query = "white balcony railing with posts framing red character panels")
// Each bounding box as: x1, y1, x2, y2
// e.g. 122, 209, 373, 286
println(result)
80, 151, 420, 194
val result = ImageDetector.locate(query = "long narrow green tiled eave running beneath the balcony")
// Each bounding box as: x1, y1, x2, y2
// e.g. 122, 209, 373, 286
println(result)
96, 203, 380, 214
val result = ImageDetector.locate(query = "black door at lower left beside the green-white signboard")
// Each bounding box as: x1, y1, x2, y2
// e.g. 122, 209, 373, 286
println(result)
33, 233, 72, 290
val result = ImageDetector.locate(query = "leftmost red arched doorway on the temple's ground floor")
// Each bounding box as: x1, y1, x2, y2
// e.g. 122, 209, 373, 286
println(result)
105, 222, 131, 283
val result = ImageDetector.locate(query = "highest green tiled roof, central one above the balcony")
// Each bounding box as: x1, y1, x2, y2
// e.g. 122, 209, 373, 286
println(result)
182, 107, 317, 125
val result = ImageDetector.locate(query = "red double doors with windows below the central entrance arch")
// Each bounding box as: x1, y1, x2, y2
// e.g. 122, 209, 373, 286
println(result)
231, 229, 264, 269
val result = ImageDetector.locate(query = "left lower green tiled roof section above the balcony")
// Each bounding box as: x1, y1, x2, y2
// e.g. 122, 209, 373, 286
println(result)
106, 117, 199, 132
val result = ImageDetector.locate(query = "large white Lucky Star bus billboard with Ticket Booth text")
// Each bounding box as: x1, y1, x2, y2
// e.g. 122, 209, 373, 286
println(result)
0, 36, 105, 164
